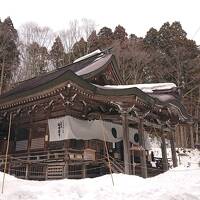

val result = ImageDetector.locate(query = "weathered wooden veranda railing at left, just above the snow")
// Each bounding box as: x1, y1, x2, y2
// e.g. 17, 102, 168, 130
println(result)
0, 148, 99, 180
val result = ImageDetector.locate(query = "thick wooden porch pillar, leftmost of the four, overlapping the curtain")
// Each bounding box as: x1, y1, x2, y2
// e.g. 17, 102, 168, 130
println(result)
122, 112, 131, 174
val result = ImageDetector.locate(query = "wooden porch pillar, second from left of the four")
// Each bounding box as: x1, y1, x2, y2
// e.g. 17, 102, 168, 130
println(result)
138, 117, 147, 178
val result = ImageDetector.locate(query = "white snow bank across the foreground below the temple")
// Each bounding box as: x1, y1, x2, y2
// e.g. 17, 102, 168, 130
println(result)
0, 168, 200, 200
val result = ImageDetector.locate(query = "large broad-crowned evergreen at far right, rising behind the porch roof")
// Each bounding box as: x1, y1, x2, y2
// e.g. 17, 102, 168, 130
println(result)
144, 22, 199, 90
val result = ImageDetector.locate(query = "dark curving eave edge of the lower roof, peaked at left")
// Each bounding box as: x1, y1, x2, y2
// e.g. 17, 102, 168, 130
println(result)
0, 70, 191, 121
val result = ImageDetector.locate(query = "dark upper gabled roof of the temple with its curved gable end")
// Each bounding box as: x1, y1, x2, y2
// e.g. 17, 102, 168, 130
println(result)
0, 52, 123, 101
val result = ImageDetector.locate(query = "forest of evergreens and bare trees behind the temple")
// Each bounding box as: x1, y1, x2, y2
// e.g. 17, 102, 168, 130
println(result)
0, 17, 200, 126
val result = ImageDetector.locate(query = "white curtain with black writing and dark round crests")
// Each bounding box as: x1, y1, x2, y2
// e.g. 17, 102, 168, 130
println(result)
48, 116, 150, 148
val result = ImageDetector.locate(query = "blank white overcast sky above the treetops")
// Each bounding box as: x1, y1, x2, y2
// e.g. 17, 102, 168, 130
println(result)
0, 0, 200, 44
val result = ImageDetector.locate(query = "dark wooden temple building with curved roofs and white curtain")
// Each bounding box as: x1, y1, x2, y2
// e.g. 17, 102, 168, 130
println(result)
0, 49, 191, 180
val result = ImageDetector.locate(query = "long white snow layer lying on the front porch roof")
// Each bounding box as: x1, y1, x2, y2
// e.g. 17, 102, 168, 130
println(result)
96, 83, 176, 93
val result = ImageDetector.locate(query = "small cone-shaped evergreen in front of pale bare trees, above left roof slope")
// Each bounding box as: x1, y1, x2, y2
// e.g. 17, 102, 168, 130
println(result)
50, 36, 66, 68
